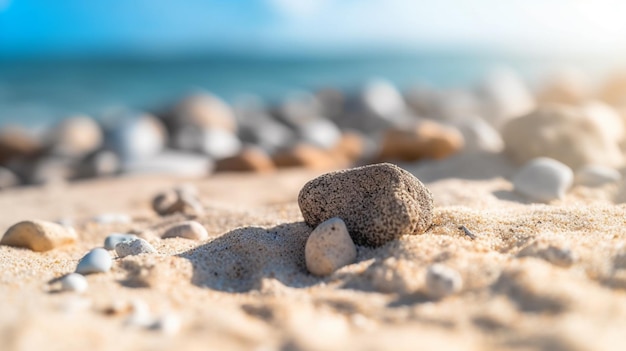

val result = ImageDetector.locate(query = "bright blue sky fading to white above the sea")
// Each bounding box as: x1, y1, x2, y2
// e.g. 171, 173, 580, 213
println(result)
0, 0, 626, 56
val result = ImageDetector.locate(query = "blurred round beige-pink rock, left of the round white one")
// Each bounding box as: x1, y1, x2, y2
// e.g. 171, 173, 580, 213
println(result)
50, 116, 104, 158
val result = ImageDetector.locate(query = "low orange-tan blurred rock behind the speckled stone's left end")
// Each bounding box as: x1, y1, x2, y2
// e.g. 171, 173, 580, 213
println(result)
272, 144, 345, 169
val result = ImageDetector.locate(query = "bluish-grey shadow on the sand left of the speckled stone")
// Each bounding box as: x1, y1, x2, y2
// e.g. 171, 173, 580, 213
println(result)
178, 222, 319, 292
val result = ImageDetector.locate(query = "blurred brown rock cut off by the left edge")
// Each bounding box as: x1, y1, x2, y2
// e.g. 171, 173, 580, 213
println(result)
0, 126, 43, 165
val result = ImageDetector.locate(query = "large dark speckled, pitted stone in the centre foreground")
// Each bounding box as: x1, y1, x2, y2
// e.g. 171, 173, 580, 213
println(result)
298, 163, 433, 247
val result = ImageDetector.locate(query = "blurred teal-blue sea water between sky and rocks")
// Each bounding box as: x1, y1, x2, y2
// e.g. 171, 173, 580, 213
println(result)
0, 52, 617, 128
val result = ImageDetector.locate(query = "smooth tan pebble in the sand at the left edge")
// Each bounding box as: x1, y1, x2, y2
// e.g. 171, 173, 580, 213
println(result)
0, 220, 77, 252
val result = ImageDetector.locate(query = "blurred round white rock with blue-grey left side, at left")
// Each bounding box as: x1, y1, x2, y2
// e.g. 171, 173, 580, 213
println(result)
106, 113, 167, 162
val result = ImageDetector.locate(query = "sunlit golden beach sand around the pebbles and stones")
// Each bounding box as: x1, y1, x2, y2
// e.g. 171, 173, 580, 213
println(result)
0, 155, 626, 351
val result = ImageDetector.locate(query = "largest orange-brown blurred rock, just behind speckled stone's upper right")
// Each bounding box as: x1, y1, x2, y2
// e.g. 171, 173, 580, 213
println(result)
378, 121, 464, 162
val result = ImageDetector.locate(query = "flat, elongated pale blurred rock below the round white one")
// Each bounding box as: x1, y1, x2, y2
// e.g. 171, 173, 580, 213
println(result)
122, 150, 214, 177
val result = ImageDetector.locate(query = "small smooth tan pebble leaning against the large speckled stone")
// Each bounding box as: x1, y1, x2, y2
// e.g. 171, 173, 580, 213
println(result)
304, 218, 356, 276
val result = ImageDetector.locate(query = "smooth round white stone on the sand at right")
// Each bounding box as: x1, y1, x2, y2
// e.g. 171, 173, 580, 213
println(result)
513, 157, 574, 202
